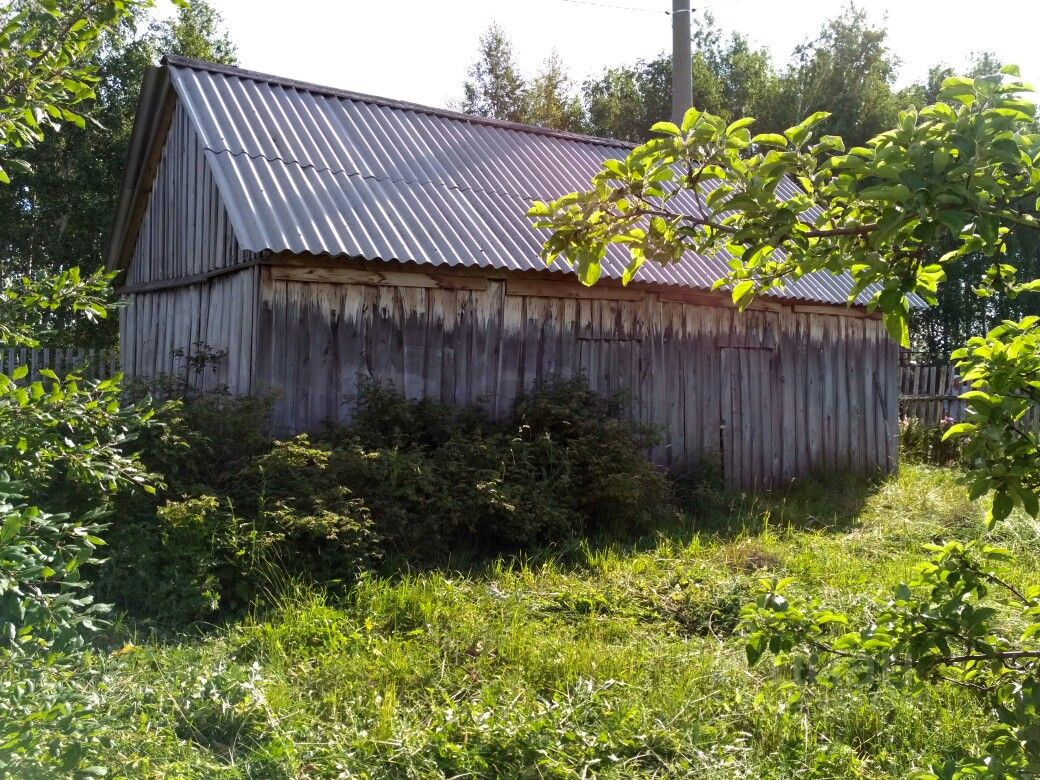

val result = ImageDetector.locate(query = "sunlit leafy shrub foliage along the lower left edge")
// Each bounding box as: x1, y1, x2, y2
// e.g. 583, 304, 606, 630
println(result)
0, 274, 157, 777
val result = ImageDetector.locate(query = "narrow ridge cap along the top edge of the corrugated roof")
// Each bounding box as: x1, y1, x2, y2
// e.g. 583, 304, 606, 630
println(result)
162, 54, 636, 149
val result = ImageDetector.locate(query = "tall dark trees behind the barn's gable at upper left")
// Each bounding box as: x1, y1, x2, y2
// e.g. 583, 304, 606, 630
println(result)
0, 0, 234, 344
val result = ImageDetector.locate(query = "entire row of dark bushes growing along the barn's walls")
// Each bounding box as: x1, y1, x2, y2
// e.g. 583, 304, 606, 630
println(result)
104, 382, 675, 620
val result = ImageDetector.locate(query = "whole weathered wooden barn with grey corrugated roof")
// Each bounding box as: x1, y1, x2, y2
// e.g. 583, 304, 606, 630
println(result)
108, 56, 919, 487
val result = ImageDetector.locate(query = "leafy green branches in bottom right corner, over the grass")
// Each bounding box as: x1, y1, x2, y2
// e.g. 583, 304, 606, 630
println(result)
742, 542, 1040, 778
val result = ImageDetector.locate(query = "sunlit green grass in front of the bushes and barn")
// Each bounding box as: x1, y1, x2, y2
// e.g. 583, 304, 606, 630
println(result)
97, 466, 1040, 778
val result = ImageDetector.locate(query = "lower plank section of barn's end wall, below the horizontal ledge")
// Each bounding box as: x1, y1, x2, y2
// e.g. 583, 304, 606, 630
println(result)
120, 266, 259, 393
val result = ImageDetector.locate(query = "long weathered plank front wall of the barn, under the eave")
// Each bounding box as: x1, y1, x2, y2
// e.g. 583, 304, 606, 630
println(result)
255, 268, 899, 487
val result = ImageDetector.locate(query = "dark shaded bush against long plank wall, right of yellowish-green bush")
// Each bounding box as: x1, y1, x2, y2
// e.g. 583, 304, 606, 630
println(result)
322, 381, 673, 562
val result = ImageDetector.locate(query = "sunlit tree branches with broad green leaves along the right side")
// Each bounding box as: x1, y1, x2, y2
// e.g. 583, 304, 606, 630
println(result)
529, 67, 1040, 778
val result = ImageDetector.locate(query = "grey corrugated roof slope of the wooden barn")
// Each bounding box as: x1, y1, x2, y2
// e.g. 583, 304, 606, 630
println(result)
158, 57, 915, 304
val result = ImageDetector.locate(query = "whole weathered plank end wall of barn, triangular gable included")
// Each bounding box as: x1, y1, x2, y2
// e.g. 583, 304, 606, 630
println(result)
120, 104, 258, 393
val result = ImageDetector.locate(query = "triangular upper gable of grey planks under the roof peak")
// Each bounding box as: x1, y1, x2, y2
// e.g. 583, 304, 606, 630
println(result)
125, 104, 243, 287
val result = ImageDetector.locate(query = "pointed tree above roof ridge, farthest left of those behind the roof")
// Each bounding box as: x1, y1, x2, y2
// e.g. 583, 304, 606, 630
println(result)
462, 25, 527, 122
